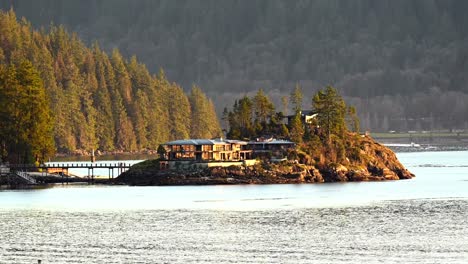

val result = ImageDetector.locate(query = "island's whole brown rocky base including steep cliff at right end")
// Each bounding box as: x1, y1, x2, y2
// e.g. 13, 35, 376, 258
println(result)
116, 136, 414, 185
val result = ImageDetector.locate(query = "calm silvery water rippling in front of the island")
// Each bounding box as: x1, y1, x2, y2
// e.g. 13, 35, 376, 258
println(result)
0, 151, 468, 263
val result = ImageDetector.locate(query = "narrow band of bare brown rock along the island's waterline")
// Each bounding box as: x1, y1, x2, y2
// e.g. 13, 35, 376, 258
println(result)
116, 166, 413, 186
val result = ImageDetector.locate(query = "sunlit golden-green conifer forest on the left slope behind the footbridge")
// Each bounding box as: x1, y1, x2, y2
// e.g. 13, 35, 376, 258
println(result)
0, 10, 221, 162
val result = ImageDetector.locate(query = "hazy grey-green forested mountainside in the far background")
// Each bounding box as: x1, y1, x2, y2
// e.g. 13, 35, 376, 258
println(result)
0, 0, 468, 131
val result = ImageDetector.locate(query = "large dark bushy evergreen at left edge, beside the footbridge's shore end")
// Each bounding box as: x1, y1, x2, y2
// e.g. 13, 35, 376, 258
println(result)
0, 60, 55, 163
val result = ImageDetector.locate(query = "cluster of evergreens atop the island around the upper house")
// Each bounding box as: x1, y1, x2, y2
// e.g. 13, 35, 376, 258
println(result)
222, 85, 360, 143
